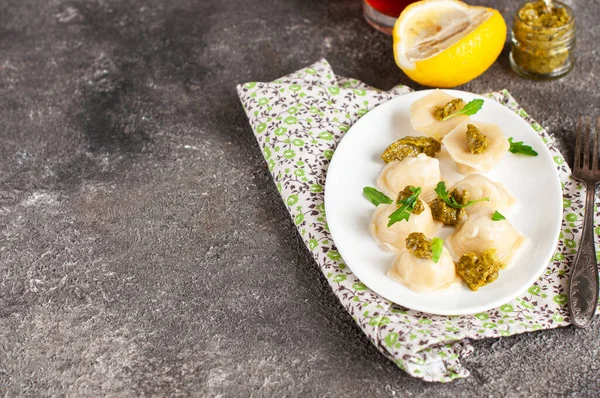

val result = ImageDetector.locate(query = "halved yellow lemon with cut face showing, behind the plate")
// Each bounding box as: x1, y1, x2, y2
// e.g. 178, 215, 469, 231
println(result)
393, 0, 506, 88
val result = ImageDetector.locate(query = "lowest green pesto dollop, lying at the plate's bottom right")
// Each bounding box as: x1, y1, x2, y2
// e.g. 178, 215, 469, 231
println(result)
456, 249, 504, 291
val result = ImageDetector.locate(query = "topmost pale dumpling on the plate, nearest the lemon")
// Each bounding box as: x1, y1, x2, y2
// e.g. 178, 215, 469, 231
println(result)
408, 90, 470, 139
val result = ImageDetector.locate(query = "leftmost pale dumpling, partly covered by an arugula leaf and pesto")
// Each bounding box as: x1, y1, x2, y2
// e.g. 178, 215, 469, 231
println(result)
369, 200, 439, 252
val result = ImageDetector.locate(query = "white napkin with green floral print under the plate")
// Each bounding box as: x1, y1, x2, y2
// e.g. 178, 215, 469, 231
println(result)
237, 60, 600, 382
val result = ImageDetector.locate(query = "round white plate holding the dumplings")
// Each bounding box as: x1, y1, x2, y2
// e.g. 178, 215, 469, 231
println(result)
325, 90, 562, 315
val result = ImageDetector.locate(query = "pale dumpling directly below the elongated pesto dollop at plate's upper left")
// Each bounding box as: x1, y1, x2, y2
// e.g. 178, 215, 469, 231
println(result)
377, 153, 442, 201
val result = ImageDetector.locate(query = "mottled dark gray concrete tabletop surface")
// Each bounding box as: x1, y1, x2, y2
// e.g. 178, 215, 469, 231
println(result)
0, 0, 600, 397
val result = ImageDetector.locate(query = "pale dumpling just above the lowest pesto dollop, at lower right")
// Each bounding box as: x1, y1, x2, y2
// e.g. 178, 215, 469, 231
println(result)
446, 207, 527, 266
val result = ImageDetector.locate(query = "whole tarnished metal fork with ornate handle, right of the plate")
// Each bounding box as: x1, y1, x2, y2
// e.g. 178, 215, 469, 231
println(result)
569, 117, 600, 328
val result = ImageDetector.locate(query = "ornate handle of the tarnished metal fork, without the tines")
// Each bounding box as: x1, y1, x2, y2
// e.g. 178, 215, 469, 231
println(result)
569, 183, 598, 328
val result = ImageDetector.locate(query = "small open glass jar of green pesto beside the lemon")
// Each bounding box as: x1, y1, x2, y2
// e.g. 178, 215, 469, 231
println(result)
510, 0, 575, 79
